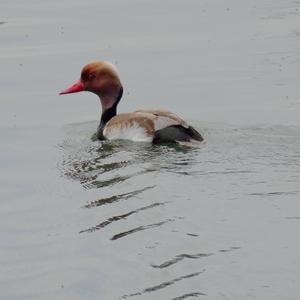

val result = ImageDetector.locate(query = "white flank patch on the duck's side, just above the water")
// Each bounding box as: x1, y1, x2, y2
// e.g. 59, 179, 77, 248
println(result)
103, 122, 153, 142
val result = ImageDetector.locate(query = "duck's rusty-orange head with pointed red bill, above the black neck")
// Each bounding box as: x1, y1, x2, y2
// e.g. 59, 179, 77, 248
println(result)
60, 61, 123, 110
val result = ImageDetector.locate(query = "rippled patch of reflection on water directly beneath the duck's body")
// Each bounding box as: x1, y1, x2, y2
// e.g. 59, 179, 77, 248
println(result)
60, 141, 196, 189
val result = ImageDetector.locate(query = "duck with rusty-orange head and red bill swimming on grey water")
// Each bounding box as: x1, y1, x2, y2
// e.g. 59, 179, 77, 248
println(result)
60, 61, 204, 144
